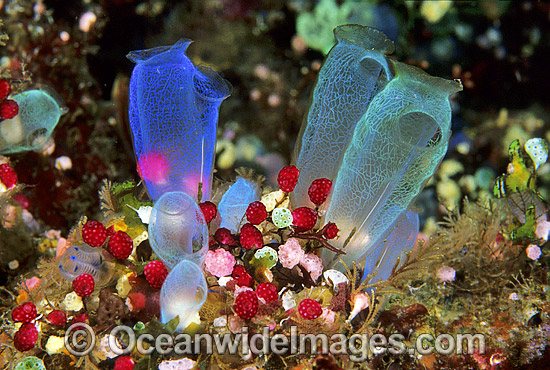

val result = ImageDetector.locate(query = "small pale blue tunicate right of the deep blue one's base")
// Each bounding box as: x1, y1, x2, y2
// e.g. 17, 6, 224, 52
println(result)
218, 177, 260, 233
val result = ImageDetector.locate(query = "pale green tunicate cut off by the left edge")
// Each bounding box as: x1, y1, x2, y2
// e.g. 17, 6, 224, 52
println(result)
0, 87, 67, 154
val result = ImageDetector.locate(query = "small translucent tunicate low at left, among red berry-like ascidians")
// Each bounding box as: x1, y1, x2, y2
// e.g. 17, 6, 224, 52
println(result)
59, 244, 112, 286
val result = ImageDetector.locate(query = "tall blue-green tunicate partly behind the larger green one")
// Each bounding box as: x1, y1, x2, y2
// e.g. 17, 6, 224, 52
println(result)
293, 26, 394, 211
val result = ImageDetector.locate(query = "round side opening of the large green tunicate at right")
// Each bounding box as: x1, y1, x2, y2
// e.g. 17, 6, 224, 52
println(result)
397, 112, 442, 148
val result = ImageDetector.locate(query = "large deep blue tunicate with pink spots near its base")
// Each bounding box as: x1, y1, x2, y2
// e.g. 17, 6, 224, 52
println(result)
127, 39, 231, 199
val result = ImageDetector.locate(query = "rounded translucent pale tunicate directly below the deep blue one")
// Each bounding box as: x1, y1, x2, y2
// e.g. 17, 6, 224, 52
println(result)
149, 191, 208, 269
